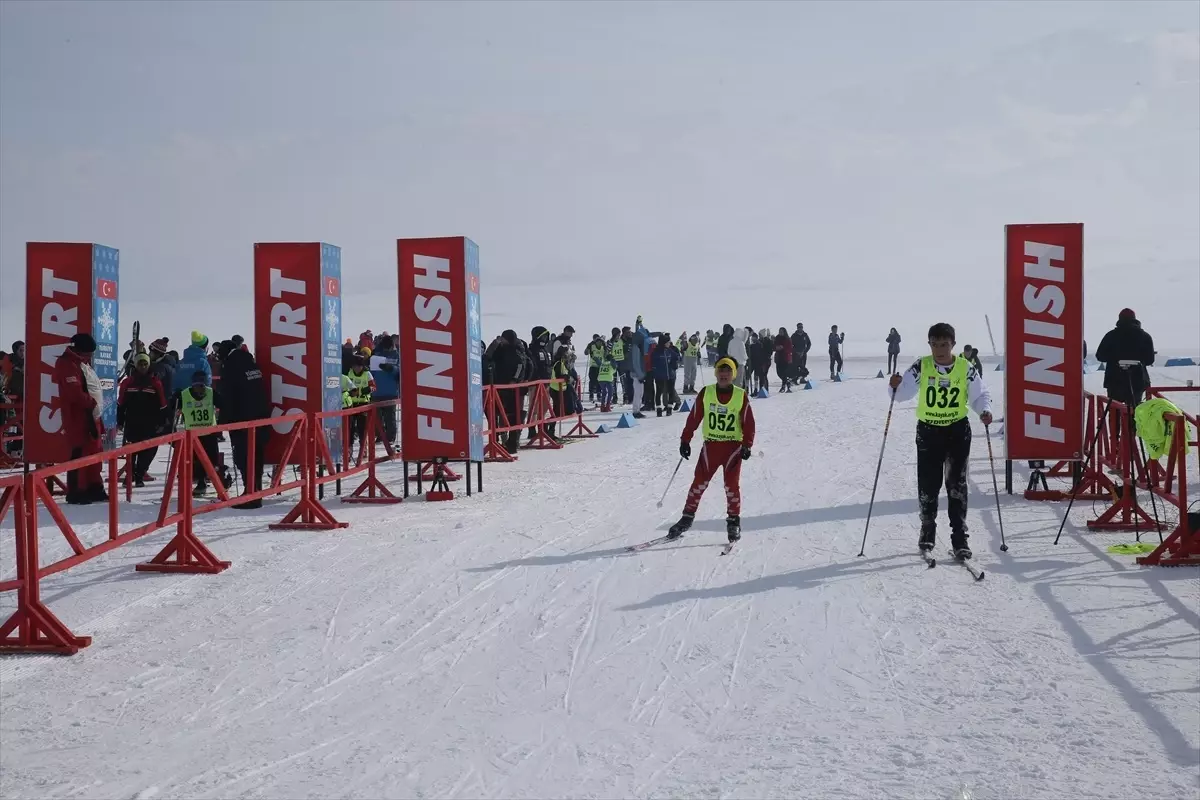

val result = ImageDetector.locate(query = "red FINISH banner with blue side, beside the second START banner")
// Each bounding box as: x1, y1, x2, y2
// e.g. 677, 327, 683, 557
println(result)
396, 236, 484, 462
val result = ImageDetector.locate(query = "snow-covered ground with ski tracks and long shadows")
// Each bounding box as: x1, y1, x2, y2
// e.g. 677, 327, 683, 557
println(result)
0, 363, 1200, 800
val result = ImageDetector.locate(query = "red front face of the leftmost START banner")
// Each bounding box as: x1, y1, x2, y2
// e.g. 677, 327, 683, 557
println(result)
23, 242, 99, 464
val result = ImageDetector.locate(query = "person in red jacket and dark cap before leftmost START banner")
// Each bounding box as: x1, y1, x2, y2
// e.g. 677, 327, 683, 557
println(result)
53, 333, 108, 505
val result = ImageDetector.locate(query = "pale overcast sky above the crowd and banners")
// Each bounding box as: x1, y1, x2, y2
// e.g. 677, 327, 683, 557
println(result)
0, 0, 1200, 355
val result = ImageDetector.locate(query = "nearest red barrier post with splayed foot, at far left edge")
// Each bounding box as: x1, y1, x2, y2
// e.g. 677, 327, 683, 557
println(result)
0, 481, 91, 656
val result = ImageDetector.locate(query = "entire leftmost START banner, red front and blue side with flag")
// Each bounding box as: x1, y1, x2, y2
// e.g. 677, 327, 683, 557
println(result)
23, 242, 121, 464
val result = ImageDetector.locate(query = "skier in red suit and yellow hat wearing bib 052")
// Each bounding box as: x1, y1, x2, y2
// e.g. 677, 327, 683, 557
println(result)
667, 357, 754, 542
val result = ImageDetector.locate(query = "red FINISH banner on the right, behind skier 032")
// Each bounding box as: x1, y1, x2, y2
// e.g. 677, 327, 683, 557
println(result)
1004, 223, 1084, 461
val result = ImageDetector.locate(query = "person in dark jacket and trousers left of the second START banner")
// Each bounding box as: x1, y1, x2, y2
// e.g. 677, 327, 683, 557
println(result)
221, 342, 271, 509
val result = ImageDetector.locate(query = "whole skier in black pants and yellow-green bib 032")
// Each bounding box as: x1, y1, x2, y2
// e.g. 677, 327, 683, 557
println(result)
888, 323, 991, 560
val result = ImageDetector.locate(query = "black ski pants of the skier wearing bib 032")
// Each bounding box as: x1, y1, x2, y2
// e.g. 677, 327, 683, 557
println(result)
917, 419, 971, 533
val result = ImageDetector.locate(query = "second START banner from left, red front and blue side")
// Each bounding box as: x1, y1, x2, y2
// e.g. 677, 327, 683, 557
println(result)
254, 242, 342, 462
